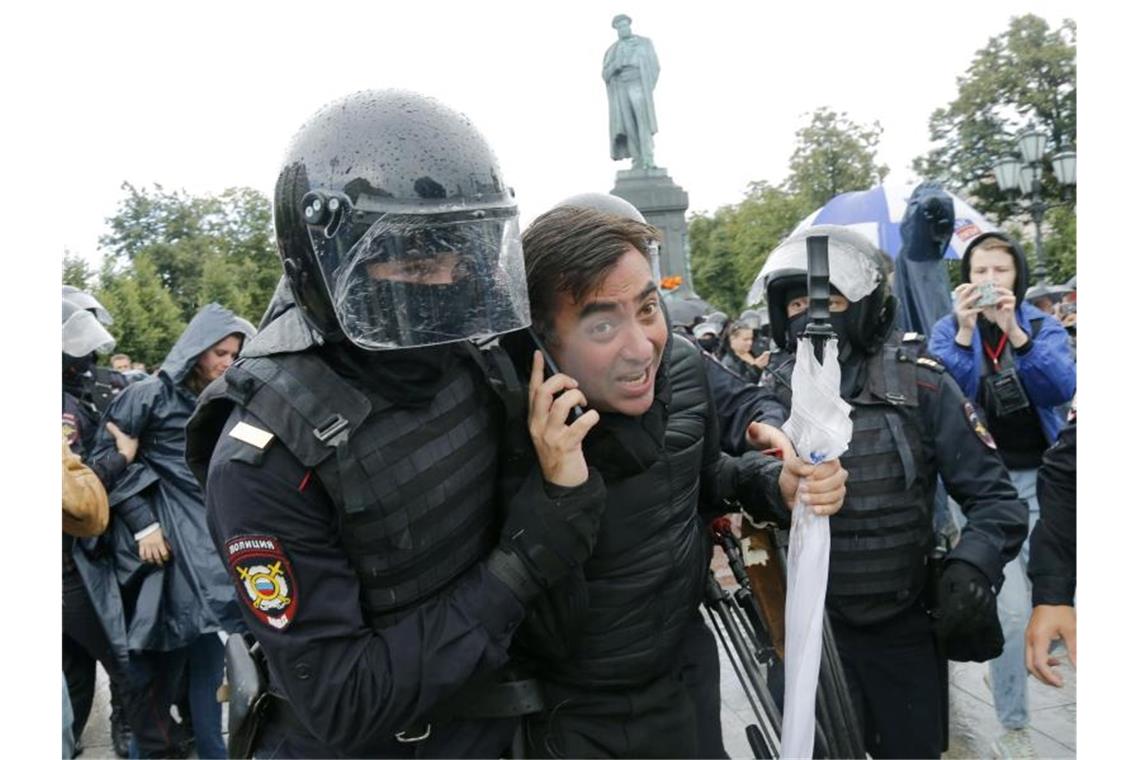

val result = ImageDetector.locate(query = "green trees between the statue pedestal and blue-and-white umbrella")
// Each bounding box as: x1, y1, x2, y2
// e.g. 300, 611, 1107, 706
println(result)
689, 108, 888, 314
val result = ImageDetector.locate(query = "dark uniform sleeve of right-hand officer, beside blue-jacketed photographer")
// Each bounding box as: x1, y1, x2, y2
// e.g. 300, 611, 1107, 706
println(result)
918, 365, 1029, 588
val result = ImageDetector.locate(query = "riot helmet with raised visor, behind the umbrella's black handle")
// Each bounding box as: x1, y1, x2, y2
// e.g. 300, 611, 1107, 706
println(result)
749, 224, 897, 354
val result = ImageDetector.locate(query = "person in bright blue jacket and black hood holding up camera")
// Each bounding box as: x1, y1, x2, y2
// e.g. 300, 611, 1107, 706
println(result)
929, 232, 1076, 757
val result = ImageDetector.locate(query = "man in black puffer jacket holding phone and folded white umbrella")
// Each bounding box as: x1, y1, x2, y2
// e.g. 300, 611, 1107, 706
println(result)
503, 207, 846, 757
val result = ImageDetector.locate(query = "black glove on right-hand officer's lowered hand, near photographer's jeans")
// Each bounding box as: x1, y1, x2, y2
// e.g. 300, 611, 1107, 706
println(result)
935, 559, 1004, 662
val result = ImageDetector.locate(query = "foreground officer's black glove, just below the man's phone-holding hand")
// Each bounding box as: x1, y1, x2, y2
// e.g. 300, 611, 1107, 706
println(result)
490, 467, 605, 602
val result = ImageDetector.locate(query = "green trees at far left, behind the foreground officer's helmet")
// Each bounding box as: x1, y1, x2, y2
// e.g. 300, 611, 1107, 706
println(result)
99, 182, 280, 321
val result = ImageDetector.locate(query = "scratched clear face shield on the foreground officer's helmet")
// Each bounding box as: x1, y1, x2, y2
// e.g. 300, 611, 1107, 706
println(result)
309, 207, 530, 351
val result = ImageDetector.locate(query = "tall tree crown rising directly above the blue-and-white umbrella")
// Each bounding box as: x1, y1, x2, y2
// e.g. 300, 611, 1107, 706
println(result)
784, 107, 889, 209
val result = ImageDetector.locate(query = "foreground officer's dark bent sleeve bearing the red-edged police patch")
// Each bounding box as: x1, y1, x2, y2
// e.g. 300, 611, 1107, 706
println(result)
206, 403, 604, 757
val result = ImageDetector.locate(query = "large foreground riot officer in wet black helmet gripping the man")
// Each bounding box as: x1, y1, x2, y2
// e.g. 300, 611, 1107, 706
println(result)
187, 91, 604, 757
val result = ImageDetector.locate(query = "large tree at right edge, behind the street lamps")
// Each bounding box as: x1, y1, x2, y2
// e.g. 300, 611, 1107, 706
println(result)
913, 15, 1076, 279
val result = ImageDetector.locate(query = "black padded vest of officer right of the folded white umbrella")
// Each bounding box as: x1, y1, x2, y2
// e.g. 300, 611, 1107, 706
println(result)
775, 336, 937, 626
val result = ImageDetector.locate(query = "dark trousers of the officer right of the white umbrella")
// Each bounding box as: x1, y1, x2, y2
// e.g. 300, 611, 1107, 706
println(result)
831, 606, 943, 758
